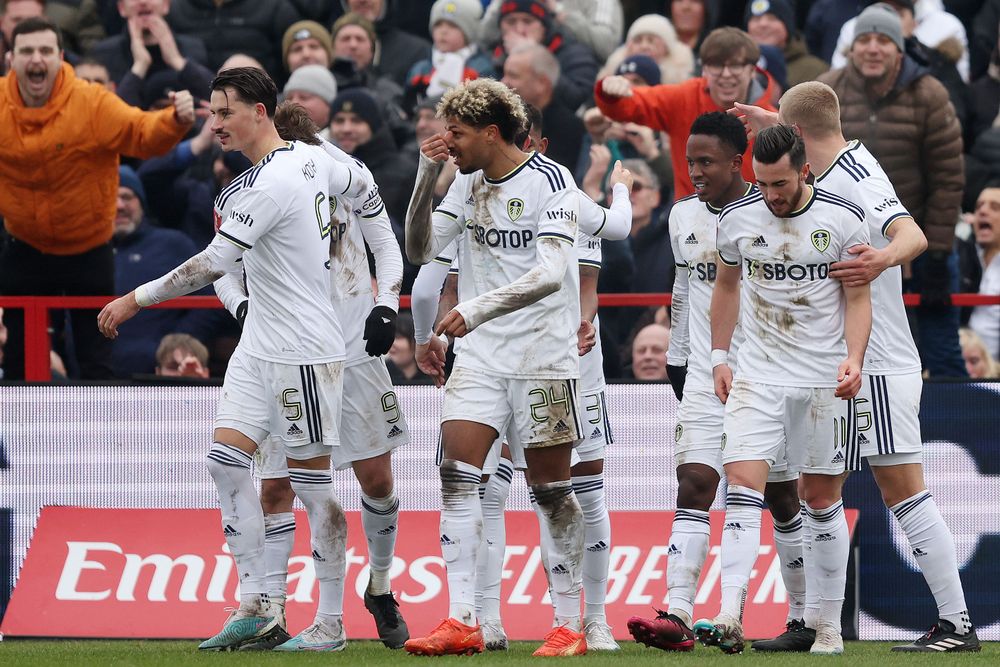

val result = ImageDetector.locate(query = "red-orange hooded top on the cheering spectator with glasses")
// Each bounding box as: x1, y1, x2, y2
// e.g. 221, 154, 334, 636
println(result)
594, 68, 775, 199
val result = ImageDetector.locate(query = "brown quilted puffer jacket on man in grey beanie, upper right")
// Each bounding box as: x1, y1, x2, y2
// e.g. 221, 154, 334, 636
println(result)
819, 56, 965, 252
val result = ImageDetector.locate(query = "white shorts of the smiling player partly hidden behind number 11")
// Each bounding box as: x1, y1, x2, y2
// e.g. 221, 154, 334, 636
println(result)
674, 389, 799, 482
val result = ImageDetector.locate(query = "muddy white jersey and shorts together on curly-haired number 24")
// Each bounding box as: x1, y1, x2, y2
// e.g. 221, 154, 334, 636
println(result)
421, 153, 582, 460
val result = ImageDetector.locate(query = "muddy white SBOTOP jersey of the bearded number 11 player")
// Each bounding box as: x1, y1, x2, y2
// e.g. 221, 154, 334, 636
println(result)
718, 187, 869, 388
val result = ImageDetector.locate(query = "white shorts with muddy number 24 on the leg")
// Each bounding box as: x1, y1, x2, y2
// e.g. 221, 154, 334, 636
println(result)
441, 368, 583, 462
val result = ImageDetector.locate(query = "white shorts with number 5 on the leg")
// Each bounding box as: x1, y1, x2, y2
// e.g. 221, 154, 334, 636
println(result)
215, 348, 344, 460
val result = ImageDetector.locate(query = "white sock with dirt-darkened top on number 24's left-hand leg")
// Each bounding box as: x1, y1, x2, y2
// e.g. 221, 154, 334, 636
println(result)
440, 459, 483, 625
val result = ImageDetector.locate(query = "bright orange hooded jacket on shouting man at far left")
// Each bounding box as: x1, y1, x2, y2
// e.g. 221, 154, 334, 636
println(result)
0, 63, 189, 255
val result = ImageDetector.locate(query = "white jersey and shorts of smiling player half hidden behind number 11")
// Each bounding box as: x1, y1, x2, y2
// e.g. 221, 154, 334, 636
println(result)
667, 184, 797, 482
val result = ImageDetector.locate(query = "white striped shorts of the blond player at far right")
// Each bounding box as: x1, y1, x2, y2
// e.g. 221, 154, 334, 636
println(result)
849, 372, 924, 470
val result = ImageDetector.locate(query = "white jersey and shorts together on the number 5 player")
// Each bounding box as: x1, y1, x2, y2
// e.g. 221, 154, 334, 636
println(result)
215, 142, 367, 459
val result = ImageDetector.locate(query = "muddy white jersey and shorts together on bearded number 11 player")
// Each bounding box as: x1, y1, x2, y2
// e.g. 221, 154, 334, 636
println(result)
718, 186, 869, 475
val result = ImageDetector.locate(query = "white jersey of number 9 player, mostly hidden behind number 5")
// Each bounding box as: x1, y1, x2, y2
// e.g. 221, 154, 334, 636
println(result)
323, 142, 403, 366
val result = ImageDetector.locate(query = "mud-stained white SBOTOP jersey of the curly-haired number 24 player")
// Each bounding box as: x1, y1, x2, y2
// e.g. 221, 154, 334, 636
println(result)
433, 153, 580, 379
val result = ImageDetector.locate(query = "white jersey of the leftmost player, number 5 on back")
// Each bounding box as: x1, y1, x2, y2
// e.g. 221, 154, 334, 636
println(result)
215, 141, 366, 364
